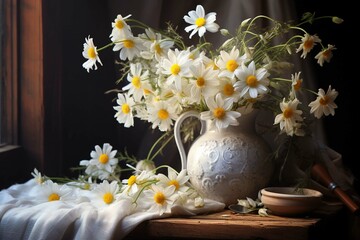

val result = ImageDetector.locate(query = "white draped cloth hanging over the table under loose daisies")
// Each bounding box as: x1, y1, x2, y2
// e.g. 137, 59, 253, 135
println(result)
0, 179, 225, 240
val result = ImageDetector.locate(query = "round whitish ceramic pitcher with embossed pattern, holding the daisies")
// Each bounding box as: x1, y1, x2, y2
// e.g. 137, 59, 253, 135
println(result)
174, 111, 273, 205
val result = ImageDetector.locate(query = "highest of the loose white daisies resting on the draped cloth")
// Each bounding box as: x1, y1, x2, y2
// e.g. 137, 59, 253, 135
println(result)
80, 143, 118, 180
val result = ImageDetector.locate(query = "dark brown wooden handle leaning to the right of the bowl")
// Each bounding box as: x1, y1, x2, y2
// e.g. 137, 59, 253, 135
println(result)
311, 163, 360, 214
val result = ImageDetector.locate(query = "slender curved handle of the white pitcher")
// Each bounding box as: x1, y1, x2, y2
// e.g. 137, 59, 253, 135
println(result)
174, 111, 205, 169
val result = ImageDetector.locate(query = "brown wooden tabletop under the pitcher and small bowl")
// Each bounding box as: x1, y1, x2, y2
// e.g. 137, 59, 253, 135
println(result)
126, 202, 345, 240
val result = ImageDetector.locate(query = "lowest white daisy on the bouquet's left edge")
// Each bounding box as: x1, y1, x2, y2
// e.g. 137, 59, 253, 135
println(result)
113, 93, 135, 128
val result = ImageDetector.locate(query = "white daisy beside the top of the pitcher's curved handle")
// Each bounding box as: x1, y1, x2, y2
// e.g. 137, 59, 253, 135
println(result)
148, 101, 178, 131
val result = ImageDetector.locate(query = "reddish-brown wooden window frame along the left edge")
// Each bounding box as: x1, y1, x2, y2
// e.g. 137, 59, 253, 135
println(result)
0, 0, 62, 188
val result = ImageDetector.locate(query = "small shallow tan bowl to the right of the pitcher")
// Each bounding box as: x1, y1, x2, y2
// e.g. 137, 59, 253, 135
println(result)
260, 187, 323, 216
